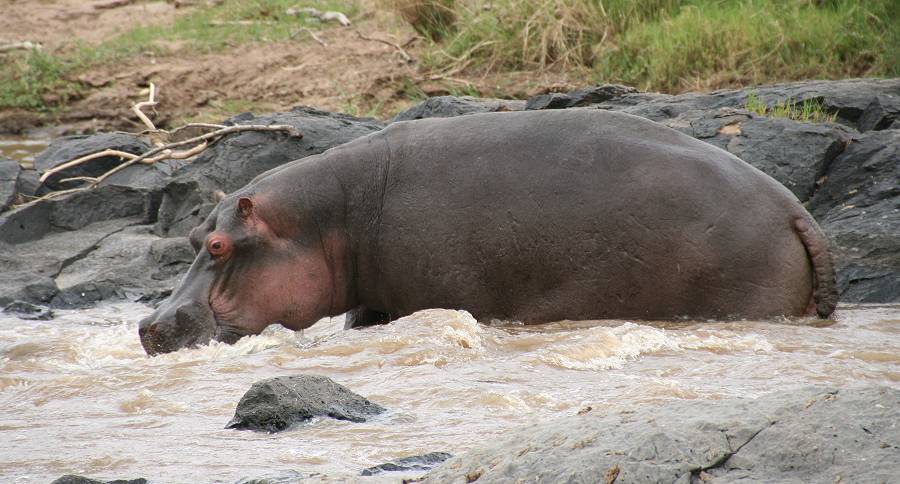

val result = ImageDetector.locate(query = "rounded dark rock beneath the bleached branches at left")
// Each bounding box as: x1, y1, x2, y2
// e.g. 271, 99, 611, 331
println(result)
34, 133, 150, 190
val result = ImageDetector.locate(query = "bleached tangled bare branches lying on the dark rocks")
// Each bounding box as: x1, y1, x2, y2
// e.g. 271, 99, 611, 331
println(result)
35, 82, 303, 201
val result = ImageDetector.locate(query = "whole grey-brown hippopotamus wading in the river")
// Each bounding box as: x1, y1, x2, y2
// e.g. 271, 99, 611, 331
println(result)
139, 109, 837, 354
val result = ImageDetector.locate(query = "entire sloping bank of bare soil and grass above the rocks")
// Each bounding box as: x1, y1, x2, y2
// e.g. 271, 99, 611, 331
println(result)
0, 0, 900, 131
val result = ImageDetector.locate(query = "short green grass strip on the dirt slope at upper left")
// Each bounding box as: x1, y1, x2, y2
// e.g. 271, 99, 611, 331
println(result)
0, 0, 359, 111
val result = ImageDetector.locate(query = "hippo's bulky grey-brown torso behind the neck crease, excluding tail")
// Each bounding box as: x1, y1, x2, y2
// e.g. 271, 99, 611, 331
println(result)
360, 110, 811, 321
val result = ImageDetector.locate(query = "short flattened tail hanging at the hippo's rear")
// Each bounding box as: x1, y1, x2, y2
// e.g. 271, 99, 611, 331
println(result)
794, 213, 838, 318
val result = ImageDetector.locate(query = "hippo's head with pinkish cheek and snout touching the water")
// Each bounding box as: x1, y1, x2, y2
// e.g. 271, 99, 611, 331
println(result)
139, 195, 346, 355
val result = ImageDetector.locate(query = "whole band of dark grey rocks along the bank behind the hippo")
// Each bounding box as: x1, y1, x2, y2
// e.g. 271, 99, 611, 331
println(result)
0, 79, 900, 314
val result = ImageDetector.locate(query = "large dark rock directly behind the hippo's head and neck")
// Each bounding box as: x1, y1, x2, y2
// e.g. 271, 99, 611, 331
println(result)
156, 107, 383, 235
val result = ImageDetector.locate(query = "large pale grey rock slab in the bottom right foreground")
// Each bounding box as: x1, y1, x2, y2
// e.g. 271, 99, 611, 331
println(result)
423, 387, 900, 484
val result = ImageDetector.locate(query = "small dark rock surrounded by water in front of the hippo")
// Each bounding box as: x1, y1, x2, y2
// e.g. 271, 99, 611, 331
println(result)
225, 375, 385, 432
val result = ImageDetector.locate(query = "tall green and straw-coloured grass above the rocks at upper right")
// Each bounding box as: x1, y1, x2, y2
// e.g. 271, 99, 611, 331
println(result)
410, 0, 900, 92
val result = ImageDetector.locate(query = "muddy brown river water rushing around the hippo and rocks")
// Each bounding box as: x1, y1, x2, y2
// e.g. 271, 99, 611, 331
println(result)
0, 303, 900, 483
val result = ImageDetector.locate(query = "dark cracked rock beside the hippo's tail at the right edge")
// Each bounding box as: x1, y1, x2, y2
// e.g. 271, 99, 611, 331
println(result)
810, 130, 900, 303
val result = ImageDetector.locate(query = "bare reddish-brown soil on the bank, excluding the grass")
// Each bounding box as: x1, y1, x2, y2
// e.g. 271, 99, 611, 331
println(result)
0, 0, 574, 133
